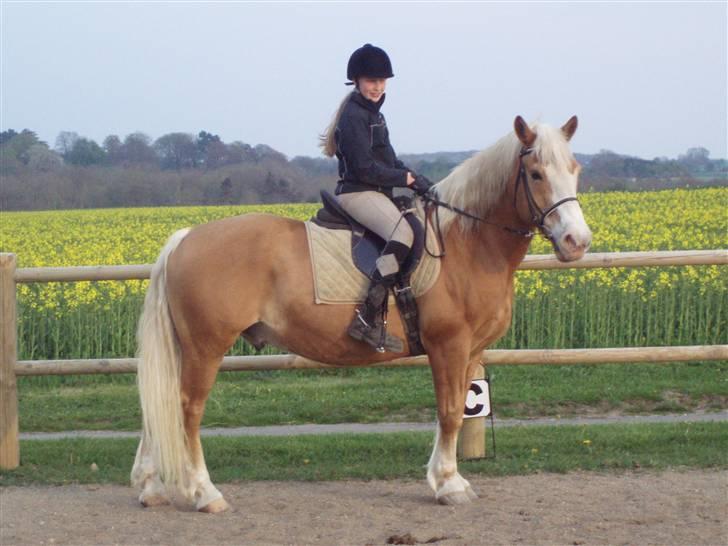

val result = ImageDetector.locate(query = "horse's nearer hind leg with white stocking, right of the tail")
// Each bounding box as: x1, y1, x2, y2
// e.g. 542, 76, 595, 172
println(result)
181, 352, 229, 513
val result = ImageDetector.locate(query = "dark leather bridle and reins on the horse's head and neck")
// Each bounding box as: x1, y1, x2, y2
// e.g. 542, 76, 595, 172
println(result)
422, 146, 579, 258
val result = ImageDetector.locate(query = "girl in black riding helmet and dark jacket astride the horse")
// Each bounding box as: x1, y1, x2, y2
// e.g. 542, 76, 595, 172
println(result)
321, 44, 430, 352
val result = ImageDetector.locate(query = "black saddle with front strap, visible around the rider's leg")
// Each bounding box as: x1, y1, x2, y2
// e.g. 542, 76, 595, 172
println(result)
311, 190, 425, 355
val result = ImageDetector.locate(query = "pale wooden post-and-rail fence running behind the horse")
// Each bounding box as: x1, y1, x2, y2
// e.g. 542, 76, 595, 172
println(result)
0, 249, 728, 469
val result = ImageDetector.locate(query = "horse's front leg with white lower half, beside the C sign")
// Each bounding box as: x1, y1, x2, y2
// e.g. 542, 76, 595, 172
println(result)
427, 343, 480, 504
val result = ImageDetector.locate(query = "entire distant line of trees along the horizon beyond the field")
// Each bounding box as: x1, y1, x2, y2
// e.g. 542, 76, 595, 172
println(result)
0, 129, 728, 210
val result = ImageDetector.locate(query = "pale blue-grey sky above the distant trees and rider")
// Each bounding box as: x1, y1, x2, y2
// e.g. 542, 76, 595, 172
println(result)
0, 0, 728, 159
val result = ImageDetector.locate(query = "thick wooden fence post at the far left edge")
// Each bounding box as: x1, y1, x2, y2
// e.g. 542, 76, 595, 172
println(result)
0, 253, 20, 469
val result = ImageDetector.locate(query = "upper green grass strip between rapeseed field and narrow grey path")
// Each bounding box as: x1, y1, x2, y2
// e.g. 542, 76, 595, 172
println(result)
18, 362, 728, 432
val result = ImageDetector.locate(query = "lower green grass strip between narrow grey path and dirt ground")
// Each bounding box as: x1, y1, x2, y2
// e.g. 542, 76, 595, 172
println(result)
0, 422, 728, 486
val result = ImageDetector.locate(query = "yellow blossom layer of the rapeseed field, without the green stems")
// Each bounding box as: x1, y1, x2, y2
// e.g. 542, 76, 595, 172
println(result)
0, 188, 728, 310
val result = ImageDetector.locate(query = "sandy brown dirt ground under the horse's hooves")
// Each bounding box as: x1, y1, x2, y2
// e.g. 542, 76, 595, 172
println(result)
0, 471, 728, 545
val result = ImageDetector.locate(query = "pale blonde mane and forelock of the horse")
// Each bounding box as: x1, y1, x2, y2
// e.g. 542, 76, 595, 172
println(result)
435, 123, 574, 230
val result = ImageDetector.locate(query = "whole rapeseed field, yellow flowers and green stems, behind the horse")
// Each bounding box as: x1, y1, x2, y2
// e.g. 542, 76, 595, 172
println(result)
0, 188, 728, 359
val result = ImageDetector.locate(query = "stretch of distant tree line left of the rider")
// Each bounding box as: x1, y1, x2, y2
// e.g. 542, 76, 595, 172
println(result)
0, 129, 336, 210
